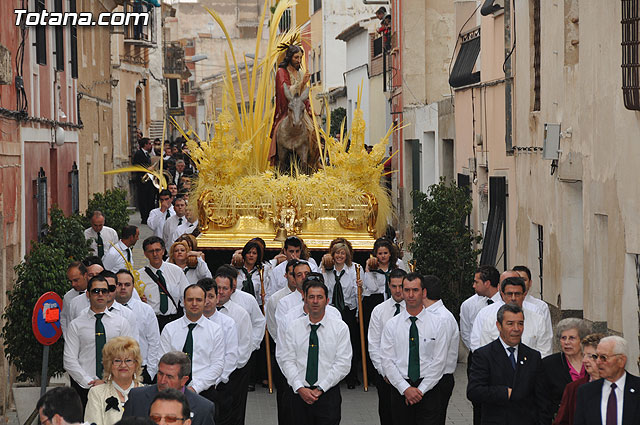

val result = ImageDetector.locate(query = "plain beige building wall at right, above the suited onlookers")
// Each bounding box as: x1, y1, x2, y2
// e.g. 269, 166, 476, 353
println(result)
515, 0, 640, 369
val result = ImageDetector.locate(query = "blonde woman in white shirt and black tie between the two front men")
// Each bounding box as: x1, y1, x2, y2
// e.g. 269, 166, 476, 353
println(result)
321, 238, 362, 389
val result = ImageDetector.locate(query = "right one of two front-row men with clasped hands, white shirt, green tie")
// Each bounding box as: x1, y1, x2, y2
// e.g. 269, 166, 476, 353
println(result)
380, 273, 449, 425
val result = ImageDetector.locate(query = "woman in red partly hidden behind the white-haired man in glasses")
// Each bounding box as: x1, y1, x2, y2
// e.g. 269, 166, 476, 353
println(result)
553, 334, 605, 425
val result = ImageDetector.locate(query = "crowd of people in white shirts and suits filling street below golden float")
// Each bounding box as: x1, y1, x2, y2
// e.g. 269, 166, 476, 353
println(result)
51, 190, 640, 425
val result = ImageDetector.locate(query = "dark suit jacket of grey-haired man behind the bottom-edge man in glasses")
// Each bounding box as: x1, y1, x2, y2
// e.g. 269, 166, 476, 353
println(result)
122, 385, 215, 425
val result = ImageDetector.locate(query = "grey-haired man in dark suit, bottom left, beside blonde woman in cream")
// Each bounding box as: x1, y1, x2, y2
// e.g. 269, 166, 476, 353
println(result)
122, 351, 215, 425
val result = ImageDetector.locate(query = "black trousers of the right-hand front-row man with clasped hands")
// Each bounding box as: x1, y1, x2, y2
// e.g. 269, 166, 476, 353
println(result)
391, 380, 440, 425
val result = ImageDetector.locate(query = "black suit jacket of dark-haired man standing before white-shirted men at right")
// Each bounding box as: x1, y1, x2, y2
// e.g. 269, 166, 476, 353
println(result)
467, 339, 551, 425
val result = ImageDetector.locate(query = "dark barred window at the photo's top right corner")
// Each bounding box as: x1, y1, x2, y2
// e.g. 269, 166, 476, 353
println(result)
621, 0, 640, 111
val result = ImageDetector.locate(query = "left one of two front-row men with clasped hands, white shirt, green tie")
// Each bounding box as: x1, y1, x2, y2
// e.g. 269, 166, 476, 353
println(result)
276, 278, 353, 424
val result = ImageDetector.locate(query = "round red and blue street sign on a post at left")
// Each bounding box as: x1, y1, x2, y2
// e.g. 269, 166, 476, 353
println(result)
31, 292, 62, 397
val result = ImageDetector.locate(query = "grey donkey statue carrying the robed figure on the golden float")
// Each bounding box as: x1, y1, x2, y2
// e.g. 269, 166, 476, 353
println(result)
276, 84, 310, 173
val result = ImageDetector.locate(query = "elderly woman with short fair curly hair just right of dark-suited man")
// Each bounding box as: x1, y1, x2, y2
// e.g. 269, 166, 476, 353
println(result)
542, 317, 591, 416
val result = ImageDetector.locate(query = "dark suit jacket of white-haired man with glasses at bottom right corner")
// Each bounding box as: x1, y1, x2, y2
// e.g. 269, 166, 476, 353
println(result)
573, 372, 640, 425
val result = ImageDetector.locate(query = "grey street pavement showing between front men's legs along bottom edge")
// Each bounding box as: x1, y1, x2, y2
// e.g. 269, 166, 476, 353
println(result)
246, 363, 473, 425
